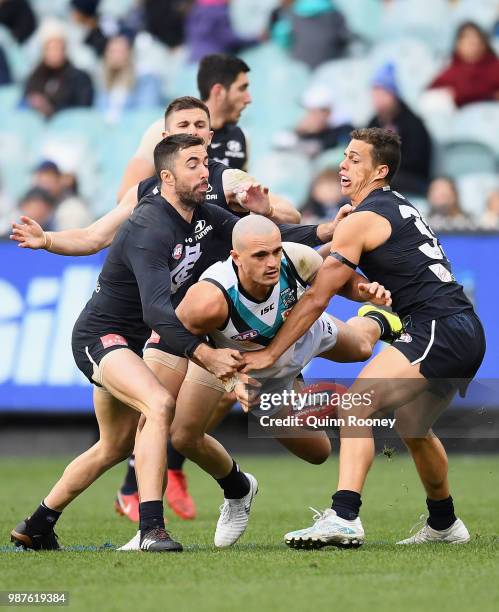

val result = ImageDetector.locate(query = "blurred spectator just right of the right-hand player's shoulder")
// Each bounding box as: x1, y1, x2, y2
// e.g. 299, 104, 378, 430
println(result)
427, 176, 474, 232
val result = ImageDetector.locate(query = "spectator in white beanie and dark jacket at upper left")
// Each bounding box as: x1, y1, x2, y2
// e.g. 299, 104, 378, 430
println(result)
23, 19, 94, 118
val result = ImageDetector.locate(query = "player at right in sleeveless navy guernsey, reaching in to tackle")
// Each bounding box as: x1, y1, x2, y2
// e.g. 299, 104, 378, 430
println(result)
244, 128, 485, 548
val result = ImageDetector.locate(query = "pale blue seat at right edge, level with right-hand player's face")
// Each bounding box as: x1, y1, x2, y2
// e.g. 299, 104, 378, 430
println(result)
439, 140, 497, 179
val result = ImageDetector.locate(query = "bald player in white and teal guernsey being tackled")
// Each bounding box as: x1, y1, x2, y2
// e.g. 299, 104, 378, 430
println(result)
117, 215, 398, 550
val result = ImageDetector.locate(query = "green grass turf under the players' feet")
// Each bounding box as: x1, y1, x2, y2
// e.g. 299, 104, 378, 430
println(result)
0, 455, 499, 612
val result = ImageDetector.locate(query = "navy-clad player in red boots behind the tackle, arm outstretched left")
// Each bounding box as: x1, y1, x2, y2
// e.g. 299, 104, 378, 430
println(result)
12, 96, 320, 521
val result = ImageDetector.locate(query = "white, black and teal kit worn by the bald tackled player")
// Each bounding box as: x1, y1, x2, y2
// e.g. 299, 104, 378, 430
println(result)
199, 242, 337, 379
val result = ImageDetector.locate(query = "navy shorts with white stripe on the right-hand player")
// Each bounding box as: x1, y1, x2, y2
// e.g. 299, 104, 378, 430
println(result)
393, 310, 485, 397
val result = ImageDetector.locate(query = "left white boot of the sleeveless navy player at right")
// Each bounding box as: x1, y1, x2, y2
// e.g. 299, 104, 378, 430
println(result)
284, 508, 364, 549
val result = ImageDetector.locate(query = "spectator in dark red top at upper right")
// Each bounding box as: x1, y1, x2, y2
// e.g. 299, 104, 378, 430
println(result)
430, 21, 499, 107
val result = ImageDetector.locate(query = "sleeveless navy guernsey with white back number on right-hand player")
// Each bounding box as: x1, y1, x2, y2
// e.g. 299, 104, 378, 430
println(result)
354, 187, 473, 321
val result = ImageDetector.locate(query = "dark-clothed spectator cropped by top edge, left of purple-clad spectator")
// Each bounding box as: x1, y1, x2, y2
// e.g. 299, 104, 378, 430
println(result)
144, 0, 194, 49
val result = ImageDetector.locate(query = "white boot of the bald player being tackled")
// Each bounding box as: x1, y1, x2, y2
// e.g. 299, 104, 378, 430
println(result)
215, 472, 258, 548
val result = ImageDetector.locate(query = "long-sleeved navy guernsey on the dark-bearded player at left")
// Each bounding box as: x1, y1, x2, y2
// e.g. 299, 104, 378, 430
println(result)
76, 188, 319, 355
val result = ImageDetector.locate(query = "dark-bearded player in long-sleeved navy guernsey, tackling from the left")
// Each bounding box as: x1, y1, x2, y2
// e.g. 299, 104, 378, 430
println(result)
11, 134, 340, 551
